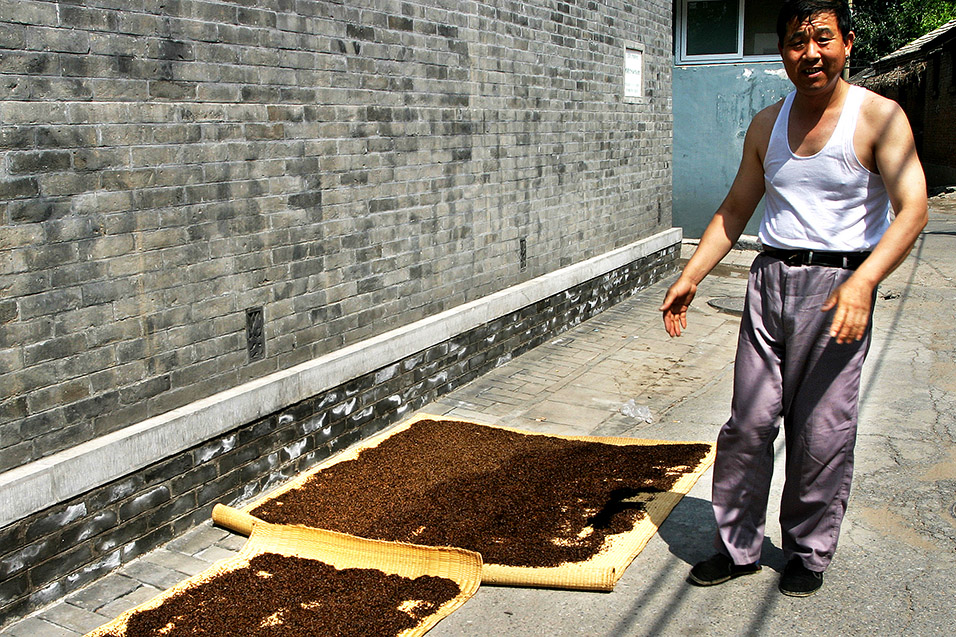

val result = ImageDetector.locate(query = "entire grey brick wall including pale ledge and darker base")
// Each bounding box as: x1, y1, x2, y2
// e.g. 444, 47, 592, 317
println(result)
0, 0, 680, 621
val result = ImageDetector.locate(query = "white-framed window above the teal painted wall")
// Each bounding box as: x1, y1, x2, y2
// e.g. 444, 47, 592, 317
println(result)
677, 0, 780, 63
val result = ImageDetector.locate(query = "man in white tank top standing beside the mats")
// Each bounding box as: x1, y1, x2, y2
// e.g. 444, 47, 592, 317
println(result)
660, 0, 927, 596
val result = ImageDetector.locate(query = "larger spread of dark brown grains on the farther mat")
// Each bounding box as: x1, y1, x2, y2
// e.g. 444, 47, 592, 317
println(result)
250, 420, 710, 567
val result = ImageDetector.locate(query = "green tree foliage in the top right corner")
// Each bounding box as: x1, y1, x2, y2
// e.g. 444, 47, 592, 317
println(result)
851, 0, 956, 72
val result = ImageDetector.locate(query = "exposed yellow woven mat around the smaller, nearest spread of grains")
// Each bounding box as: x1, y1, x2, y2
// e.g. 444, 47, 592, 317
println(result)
86, 521, 481, 637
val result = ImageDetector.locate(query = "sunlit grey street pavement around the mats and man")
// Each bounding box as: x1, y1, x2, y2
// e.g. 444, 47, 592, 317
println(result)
0, 194, 956, 637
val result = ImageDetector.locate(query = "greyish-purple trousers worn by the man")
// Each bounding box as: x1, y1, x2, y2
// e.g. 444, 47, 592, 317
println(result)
713, 254, 872, 571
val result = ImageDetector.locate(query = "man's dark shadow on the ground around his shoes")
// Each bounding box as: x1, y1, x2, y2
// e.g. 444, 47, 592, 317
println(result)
658, 496, 786, 573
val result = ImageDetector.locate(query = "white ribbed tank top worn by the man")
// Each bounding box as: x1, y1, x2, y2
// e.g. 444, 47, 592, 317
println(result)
759, 86, 892, 252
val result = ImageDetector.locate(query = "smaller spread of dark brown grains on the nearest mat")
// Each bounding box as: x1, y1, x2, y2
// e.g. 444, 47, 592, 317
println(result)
102, 553, 460, 637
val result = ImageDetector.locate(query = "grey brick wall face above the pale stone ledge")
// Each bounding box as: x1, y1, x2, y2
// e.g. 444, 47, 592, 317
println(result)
0, 0, 671, 471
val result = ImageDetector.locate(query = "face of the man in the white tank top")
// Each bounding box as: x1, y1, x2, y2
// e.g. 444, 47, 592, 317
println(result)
780, 11, 853, 95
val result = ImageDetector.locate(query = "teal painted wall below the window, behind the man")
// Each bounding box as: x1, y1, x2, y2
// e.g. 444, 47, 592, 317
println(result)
673, 62, 793, 238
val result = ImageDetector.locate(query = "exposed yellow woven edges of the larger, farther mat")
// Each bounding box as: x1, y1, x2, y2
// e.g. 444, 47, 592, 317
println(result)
213, 415, 715, 591
